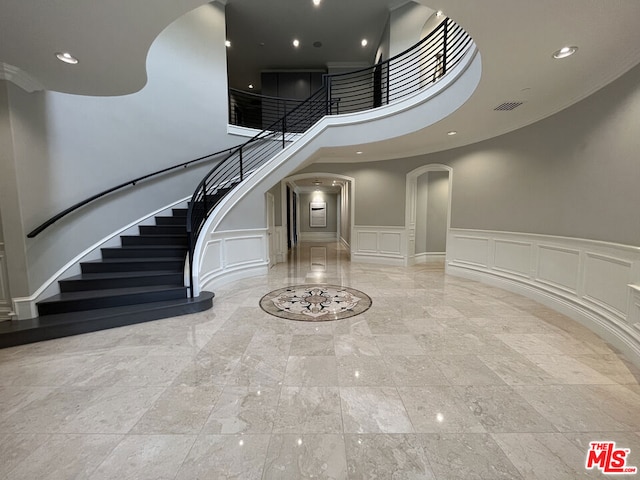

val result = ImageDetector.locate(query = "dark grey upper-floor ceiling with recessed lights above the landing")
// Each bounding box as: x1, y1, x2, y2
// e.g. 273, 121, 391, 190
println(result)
225, 0, 390, 91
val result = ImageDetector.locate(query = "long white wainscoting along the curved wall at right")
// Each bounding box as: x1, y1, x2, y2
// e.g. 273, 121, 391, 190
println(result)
446, 228, 640, 366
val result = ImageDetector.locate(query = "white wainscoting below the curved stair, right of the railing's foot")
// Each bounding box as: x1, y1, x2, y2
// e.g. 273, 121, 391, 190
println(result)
200, 229, 269, 290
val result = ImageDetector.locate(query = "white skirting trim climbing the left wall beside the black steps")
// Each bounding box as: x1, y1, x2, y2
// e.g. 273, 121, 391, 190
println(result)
13, 196, 191, 320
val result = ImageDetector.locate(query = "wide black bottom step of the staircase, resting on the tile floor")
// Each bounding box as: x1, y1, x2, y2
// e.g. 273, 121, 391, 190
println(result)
0, 292, 214, 348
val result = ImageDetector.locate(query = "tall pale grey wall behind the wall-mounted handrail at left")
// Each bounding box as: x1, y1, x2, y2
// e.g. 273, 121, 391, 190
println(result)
0, 4, 239, 300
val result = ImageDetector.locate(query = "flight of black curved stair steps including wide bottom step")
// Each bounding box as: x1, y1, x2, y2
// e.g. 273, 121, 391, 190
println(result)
0, 208, 214, 347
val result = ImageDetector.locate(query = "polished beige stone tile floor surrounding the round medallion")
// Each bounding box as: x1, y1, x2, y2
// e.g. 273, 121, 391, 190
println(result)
0, 244, 640, 480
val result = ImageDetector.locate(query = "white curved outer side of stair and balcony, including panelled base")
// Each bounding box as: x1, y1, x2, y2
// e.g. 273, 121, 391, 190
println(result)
193, 45, 482, 295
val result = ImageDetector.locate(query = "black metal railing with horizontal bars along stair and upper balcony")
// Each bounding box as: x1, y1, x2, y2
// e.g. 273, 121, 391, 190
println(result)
187, 18, 473, 296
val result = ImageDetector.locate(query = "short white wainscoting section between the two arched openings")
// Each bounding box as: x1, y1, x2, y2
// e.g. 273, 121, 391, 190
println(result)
351, 225, 406, 266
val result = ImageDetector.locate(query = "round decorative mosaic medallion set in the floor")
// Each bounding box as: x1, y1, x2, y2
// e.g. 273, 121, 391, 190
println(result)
260, 285, 371, 322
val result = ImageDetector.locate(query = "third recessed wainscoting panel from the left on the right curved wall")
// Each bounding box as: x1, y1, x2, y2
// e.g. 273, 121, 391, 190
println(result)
536, 245, 580, 294
